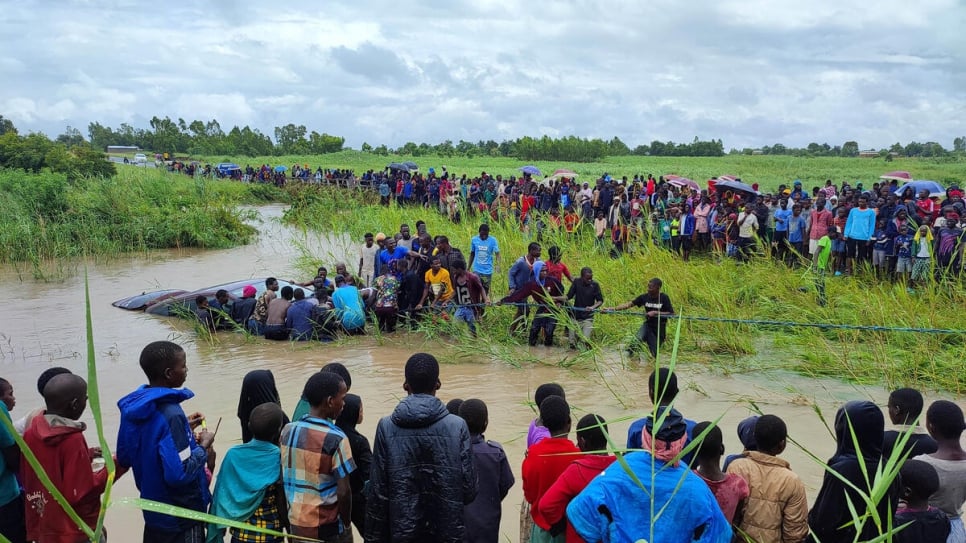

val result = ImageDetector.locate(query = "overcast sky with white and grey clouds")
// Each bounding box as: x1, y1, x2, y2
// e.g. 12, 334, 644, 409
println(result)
0, 0, 966, 149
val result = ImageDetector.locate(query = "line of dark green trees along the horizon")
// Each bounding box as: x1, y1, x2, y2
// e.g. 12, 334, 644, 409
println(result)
0, 116, 966, 166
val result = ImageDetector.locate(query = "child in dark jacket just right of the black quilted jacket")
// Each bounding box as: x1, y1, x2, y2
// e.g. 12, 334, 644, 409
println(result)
460, 399, 514, 543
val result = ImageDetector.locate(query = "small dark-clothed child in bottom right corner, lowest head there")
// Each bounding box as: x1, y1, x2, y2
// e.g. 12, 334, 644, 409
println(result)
892, 460, 950, 543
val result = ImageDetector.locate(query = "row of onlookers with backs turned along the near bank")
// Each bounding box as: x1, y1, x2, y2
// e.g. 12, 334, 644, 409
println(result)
0, 348, 966, 543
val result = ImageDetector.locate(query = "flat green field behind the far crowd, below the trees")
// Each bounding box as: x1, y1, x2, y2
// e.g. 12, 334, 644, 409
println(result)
204, 151, 966, 190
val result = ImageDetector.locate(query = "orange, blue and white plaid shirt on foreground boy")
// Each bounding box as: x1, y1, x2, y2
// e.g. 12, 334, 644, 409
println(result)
281, 415, 356, 538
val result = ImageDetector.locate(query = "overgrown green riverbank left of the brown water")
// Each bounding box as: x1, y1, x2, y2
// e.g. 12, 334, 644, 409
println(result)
0, 167, 287, 277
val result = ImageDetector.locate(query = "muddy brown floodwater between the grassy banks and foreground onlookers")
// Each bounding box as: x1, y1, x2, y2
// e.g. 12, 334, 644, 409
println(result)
0, 206, 932, 541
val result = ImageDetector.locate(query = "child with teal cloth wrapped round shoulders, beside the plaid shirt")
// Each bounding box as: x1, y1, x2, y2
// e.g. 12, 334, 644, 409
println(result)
207, 402, 288, 543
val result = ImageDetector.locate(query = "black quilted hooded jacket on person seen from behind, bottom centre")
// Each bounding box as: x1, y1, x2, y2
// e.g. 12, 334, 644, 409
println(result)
365, 394, 477, 543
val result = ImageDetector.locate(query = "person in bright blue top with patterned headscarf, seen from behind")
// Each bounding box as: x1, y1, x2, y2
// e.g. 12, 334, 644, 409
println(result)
567, 407, 732, 543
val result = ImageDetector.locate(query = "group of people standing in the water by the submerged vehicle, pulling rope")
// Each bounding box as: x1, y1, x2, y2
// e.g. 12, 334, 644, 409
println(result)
195, 221, 674, 356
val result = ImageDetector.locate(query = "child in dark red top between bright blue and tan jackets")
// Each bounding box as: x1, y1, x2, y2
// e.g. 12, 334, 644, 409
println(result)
694, 422, 749, 525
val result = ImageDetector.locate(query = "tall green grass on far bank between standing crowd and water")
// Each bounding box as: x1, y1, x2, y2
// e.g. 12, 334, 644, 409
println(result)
284, 187, 966, 393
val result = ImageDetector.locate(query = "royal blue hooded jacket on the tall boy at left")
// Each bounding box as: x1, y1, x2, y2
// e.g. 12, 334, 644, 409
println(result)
117, 385, 211, 532
